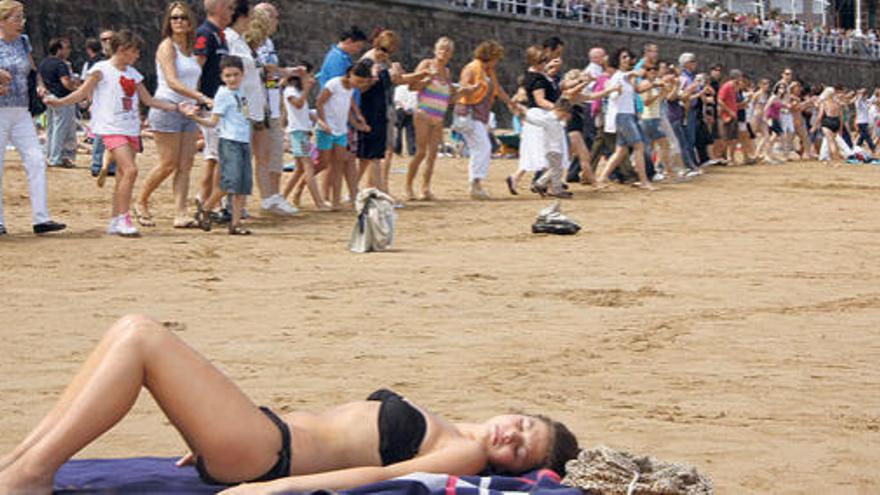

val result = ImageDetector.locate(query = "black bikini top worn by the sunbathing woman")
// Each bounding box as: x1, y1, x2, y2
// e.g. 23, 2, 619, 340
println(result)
367, 388, 428, 466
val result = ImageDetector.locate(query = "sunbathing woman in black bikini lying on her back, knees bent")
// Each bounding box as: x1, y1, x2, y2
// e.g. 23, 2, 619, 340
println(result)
0, 315, 578, 494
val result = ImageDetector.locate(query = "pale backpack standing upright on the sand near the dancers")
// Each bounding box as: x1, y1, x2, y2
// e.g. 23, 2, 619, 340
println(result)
348, 188, 397, 253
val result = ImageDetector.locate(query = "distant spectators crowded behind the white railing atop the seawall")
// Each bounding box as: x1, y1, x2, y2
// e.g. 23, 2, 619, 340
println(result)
450, 0, 880, 58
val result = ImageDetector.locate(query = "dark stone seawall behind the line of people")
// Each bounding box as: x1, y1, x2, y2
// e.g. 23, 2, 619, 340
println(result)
20, 0, 880, 90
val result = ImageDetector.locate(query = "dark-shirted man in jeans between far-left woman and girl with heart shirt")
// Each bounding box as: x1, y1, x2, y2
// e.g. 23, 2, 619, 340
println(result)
39, 38, 79, 168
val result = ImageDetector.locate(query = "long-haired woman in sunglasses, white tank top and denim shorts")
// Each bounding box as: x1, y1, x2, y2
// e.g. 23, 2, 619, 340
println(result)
134, 1, 211, 229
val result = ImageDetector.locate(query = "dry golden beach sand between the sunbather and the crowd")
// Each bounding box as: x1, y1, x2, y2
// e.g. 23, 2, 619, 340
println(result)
0, 142, 880, 494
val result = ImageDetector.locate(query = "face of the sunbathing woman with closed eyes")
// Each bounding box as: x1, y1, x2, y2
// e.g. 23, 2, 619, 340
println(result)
485, 414, 550, 474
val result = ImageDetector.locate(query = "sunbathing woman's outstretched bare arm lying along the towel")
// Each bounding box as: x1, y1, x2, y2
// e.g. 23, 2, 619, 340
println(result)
221, 442, 486, 495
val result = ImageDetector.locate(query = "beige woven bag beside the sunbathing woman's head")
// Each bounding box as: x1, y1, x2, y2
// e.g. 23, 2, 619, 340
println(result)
562, 445, 714, 495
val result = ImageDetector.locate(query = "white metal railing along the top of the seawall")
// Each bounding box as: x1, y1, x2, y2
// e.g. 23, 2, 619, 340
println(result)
440, 0, 880, 59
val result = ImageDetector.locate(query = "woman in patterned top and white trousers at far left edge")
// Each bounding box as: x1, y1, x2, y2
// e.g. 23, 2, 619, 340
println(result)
0, 0, 65, 236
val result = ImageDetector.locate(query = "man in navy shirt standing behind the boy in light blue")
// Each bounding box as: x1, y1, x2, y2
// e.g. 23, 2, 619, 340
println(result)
194, 0, 235, 217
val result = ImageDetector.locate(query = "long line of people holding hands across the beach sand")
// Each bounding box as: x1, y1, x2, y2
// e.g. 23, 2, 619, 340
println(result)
0, 0, 880, 236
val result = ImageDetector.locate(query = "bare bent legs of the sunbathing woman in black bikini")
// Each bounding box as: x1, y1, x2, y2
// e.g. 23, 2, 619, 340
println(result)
0, 316, 281, 494
